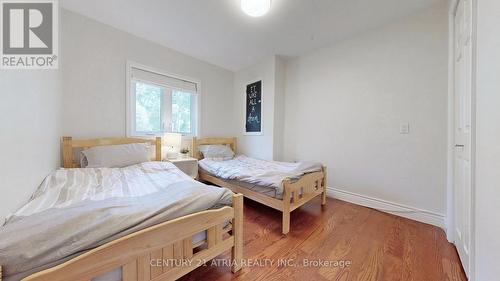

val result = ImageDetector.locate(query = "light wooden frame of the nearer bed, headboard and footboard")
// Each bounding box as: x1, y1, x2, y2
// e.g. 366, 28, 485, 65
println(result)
0, 137, 243, 281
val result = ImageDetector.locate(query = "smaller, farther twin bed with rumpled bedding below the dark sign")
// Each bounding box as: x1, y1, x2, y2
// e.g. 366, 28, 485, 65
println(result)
192, 138, 327, 234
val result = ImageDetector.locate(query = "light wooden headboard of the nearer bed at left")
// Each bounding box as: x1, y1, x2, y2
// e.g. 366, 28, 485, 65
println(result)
62, 137, 162, 168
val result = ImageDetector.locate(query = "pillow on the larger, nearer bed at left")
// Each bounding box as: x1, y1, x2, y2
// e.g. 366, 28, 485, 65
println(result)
81, 143, 150, 168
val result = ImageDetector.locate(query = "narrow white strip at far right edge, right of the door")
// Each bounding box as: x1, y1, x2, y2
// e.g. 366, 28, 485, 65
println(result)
471, 0, 500, 281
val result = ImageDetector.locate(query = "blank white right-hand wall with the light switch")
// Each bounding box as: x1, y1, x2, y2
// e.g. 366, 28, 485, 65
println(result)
285, 3, 448, 214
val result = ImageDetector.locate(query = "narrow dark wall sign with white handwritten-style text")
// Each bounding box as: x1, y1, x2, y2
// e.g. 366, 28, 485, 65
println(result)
245, 80, 262, 134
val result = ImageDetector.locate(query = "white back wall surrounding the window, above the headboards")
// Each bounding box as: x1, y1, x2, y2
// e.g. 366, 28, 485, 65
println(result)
61, 9, 233, 137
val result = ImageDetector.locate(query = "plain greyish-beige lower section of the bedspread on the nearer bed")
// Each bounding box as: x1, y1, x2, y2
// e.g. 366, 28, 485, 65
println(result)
0, 161, 232, 281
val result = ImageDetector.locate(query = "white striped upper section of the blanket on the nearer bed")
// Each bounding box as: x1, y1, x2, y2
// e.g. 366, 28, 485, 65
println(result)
7, 162, 203, 219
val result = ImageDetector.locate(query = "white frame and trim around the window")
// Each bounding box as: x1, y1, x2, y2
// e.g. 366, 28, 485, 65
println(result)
125, 61, 201, 137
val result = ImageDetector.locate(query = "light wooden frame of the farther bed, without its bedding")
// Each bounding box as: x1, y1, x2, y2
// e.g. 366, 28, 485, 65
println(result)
192, 138, 327, 234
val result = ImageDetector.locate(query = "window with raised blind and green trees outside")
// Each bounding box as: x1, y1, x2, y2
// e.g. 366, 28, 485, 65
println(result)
127, 66, 198, 136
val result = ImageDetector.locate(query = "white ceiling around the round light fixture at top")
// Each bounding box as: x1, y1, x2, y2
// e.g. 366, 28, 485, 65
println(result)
60, 0, 444, 70
